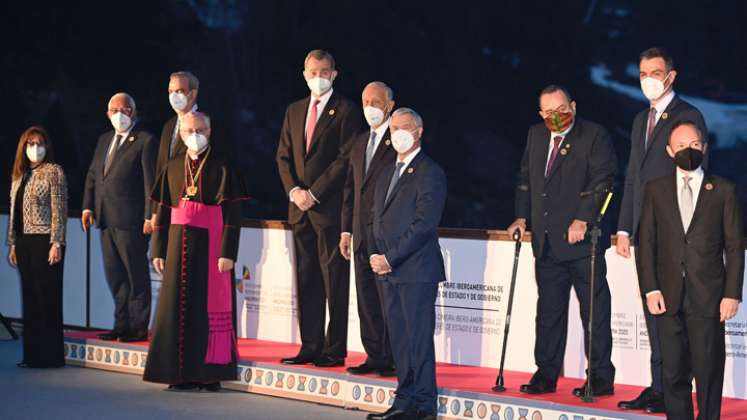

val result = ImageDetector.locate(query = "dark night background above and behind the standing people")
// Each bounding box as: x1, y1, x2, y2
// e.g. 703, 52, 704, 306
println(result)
0, 0, 747, 229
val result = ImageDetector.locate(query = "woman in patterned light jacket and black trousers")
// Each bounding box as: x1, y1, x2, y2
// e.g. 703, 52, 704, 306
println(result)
8, 127, 67, 368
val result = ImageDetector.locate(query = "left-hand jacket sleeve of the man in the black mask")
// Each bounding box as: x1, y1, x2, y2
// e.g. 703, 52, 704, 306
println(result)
638, 184, 661, 296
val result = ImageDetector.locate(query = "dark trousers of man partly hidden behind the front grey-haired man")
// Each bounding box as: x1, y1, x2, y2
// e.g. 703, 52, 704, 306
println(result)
353, 241, 393, 367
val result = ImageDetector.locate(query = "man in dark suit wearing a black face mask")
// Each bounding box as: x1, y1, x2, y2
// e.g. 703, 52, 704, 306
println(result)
638, 121, 744, 420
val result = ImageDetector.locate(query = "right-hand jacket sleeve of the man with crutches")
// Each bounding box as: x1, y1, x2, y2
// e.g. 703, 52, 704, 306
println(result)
576, 127, 617, 223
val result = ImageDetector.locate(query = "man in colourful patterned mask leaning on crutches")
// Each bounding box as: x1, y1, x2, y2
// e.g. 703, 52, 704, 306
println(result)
508, 85, 617, 396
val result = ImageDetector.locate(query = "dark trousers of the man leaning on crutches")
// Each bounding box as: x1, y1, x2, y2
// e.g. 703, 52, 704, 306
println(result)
534, 242, 615, 382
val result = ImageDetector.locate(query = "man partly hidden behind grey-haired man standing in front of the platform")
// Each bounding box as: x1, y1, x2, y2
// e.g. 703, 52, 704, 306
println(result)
340, 82, 397, 376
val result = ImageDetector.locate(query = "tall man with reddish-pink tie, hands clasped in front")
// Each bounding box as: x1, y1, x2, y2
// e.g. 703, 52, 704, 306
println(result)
277, 50, 363, 367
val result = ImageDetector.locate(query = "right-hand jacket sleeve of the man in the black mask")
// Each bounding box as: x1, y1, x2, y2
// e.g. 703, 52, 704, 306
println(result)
723, 185, 744, 300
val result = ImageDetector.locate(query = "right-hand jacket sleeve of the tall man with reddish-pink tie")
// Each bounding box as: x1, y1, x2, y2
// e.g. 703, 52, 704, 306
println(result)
309, 106, 363, 202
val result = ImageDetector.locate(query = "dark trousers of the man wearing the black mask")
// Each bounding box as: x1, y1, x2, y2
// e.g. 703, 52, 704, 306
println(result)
657, 296, 726, 420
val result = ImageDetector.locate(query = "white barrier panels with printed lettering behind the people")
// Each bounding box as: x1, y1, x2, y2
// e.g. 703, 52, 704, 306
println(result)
0, 215, 747, 398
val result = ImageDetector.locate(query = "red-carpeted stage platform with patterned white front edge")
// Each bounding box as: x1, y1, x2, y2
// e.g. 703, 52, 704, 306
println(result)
65, 332, 747, 420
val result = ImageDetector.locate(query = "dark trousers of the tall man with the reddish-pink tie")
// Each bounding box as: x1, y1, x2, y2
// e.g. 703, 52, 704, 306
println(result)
293, 215, 350, 357
